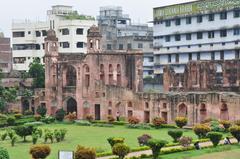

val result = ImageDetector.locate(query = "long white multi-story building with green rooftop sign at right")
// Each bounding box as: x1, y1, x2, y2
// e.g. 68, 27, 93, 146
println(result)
154, 0, 240, 76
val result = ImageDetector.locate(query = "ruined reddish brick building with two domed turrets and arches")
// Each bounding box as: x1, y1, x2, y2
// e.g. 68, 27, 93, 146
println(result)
42, 26, 240, 125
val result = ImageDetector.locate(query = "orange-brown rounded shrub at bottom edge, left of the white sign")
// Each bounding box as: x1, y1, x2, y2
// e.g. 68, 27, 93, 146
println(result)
29, 145, 51, 159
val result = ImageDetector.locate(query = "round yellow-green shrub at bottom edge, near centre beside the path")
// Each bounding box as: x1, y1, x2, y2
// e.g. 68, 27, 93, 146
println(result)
112, 143, 130, 159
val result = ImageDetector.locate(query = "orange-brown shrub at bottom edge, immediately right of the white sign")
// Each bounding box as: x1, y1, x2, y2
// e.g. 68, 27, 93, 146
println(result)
75, 145, 96, 159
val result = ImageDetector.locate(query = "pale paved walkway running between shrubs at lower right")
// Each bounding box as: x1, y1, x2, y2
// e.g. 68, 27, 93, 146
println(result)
97, 139, 237, 159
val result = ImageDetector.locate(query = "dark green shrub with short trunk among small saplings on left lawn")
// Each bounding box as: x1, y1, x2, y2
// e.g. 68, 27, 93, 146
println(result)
13, 125, 34, 142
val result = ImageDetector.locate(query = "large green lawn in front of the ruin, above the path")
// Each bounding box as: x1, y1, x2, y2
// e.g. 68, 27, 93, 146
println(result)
0, 124, 197, 159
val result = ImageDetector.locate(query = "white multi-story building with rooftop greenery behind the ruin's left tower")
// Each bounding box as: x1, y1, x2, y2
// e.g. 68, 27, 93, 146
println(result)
12, 5, 97, 71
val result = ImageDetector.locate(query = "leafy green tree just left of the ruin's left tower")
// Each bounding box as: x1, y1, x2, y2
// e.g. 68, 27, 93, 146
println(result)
28, 58, 45, 88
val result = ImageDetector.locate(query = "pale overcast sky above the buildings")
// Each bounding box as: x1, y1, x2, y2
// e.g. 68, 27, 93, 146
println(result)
0, 0, 191, 36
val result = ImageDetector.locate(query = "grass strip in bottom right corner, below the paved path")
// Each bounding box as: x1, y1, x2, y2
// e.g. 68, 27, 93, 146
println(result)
143, 145, 240, 159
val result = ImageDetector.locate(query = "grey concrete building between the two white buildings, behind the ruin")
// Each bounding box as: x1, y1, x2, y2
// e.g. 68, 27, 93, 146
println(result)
97, 6, 153, 77
